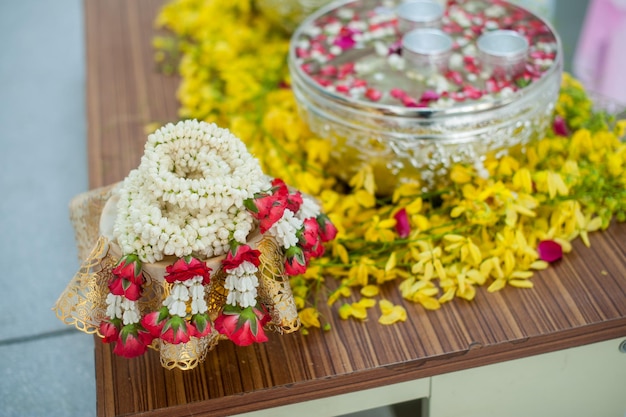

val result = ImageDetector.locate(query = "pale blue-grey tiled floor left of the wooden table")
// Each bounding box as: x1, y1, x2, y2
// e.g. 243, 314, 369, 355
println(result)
0, 0, 586, 417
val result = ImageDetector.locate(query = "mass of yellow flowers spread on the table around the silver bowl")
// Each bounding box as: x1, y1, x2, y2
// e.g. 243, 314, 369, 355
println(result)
155, 0, 626, 330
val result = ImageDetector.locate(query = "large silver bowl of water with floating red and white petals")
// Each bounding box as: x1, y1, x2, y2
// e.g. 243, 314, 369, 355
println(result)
289, 0, 563, 194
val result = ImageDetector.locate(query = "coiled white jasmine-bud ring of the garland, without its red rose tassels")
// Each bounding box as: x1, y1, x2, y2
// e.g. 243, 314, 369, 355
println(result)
114, 120, 268, 263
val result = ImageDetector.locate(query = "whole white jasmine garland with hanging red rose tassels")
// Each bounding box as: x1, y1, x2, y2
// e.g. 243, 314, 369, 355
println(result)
100, 120, 337, 358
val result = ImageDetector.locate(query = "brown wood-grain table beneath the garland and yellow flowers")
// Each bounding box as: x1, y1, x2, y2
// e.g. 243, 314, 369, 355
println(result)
84, 0, 626, 416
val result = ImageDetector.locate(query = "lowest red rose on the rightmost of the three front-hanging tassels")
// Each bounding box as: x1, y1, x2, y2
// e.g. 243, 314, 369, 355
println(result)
214, 305, 270, 346
